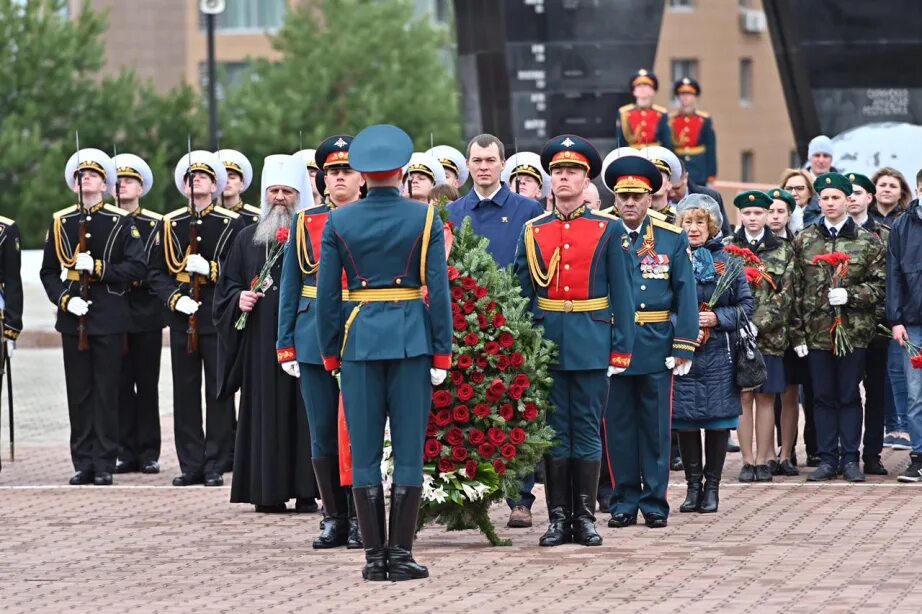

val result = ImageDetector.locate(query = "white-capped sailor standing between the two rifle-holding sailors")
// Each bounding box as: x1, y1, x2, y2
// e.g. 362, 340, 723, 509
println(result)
113, 153, 165, 473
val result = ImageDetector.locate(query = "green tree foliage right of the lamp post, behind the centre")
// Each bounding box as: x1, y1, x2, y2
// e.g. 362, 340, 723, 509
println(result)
221, 0, 461, 165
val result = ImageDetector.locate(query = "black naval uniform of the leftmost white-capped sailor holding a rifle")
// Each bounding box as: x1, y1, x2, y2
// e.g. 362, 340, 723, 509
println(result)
40, 203, 147, 474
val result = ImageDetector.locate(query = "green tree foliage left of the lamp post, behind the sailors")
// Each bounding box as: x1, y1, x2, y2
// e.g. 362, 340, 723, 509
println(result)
0, 0, 207, 247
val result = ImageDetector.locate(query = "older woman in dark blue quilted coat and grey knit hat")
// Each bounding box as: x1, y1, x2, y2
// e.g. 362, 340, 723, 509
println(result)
672, 194, 754, 513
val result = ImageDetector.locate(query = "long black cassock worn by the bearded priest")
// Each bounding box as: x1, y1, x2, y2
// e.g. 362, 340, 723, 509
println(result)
214, 224, 319, 505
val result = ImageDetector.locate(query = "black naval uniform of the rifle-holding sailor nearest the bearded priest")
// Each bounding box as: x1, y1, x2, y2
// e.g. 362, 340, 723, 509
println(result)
150, 204, 244, 481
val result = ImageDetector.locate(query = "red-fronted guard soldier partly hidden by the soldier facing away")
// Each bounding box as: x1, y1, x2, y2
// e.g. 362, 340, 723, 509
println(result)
276, 137, 362, 549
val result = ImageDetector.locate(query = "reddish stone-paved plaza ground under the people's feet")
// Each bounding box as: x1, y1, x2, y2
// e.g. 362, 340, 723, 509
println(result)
0, 349, 922, 614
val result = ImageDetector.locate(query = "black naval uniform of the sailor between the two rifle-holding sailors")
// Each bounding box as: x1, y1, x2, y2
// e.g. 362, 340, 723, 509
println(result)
118, 207, 164, 471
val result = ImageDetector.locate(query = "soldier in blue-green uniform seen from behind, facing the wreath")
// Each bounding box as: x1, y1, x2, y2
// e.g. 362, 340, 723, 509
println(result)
316, 125, 452, 581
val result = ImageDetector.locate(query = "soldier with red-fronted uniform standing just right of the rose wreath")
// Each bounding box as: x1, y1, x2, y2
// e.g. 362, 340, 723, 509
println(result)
515, 134, 634, 546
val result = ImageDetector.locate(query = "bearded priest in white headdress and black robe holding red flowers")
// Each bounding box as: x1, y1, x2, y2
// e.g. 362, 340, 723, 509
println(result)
214, 154, 317, 513
